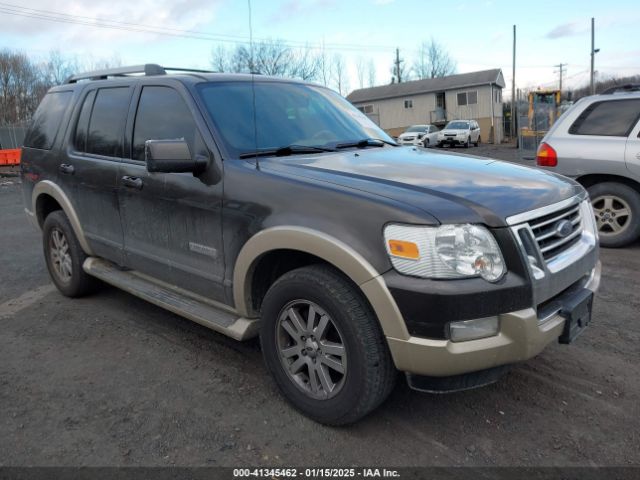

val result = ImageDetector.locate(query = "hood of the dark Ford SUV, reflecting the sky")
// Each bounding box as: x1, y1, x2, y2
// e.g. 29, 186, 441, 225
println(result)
260, 147, 583, 226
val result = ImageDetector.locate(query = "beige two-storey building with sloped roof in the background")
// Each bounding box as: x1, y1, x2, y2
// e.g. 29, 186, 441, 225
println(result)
347, 68, 505, 143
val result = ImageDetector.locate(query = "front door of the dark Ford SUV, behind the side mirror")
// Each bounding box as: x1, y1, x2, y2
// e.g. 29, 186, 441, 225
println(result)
119, 84, 224, 301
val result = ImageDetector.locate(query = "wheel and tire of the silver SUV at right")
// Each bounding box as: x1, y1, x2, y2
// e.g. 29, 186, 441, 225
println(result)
587, 182, 640, 248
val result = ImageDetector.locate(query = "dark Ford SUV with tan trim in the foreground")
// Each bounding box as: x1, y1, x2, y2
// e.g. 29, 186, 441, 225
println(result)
21, 65, 600, 425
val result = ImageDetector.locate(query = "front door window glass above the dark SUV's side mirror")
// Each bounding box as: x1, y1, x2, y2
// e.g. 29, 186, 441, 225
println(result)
132, 87, 198, 160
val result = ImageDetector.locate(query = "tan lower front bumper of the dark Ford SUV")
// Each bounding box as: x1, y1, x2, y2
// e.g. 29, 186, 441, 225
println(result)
387, 262, 601, 377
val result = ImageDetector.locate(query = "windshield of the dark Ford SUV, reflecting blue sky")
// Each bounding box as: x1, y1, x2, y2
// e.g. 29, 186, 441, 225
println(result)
198, 80, 393, 157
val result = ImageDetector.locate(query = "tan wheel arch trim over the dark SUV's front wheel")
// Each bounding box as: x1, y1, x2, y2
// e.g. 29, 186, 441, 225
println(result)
233, 226, 410, 339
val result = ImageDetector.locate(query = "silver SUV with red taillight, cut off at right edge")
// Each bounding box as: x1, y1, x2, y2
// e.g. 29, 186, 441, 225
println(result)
537, 86, 640, 247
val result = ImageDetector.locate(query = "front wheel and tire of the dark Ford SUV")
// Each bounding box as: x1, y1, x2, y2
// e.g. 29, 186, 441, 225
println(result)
260, 265, 397, 425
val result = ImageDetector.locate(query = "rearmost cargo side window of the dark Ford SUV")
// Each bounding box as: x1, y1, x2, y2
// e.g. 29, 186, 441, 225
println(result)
24, 92, 72, 150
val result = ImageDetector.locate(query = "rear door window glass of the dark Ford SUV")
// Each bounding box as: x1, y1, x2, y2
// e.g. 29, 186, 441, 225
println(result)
83, 87, 129, 157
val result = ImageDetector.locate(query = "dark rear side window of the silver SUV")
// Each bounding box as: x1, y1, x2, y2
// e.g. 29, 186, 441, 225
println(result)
569, 99, 640, 137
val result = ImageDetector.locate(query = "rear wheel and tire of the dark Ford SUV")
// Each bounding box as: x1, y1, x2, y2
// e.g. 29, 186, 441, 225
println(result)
42, 210, 98, 297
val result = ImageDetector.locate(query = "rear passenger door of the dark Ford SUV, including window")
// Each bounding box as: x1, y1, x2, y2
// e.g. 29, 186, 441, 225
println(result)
60, 86, 132, 264
